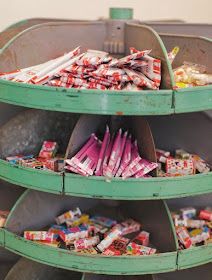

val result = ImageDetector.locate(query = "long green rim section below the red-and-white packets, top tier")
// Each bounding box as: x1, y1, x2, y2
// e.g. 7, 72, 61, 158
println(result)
0, 80, 174, 115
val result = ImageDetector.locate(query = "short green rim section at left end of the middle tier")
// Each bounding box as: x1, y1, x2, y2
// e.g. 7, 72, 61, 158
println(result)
0, 160, 63, 194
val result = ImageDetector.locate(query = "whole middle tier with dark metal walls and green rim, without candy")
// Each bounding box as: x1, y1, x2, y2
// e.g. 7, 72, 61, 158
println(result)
0, 110, 212, 200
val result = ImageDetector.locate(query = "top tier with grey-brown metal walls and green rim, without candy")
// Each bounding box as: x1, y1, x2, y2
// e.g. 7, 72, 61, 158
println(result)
0, 21, 212, 115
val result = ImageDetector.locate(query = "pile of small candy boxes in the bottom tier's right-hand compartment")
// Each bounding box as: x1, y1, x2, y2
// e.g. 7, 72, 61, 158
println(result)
172, 207, 212, 249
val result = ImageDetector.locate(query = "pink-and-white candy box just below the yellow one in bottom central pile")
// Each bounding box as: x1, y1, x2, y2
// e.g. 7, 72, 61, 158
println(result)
59, 225, 89, 243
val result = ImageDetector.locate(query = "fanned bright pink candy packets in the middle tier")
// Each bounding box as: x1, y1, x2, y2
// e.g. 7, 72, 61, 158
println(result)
65, 127, 158, 179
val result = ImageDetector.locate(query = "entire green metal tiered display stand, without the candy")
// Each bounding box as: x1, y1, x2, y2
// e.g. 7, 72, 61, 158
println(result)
0, 6, 212, 280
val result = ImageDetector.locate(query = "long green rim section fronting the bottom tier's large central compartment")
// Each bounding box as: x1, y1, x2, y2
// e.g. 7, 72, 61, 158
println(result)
5, 230, 177, 275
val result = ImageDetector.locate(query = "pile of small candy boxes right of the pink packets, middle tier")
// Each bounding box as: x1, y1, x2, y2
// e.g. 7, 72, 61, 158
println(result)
156, 149, 211, 177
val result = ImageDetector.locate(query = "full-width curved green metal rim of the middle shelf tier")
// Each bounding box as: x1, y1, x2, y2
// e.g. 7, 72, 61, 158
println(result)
0, 160, 212, 200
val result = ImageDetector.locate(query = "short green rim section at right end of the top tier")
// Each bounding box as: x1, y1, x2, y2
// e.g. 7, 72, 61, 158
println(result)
174, 86, 212, 113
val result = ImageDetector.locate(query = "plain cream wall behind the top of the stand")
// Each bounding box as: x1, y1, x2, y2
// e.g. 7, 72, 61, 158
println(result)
0, 0, 212, 30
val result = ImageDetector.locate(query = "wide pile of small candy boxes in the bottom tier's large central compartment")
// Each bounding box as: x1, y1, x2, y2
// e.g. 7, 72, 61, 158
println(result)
24, 208, 156, 256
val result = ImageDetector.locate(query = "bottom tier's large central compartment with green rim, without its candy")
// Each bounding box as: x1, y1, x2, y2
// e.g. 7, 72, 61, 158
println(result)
5, 190, 177, 275
